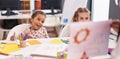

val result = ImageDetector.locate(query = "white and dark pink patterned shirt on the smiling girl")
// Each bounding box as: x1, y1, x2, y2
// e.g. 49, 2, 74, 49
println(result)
23, 27, 49, 39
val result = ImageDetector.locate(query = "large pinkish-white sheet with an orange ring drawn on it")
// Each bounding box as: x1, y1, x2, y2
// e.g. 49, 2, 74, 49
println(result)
67, 21, 110, 59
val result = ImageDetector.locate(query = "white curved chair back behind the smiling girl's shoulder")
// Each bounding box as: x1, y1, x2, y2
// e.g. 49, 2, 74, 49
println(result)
6, 24, 30, 40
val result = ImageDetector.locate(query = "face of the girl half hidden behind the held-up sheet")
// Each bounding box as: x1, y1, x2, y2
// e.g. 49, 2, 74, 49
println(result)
78, 12, 90, 22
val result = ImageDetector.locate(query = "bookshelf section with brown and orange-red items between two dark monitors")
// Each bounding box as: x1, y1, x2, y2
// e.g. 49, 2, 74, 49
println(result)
20, 0, 41, 14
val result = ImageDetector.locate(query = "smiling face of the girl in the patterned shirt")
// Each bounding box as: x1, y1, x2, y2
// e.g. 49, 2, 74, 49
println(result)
31, 14, 45, 30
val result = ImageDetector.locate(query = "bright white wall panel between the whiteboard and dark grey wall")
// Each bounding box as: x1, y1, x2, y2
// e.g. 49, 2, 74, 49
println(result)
92, 0, 110, 21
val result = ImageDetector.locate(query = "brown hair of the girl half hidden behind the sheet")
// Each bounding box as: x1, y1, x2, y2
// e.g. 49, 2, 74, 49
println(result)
72, 7, 90, 22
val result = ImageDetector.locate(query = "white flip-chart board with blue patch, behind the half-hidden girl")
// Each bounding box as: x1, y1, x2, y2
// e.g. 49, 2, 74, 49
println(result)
61, 0, 87, 25
